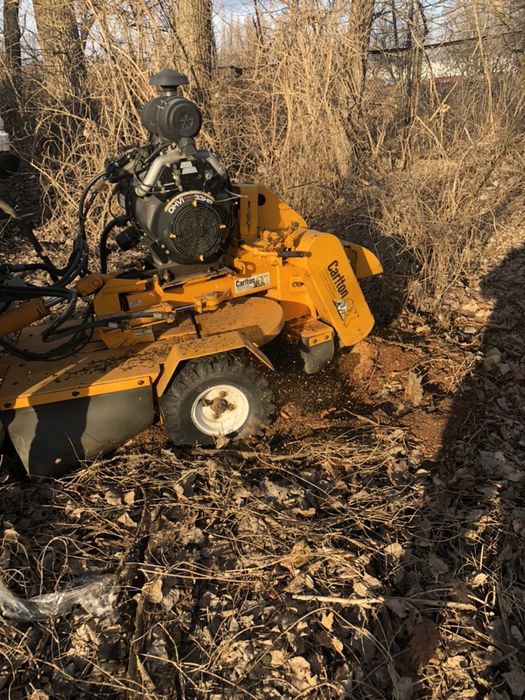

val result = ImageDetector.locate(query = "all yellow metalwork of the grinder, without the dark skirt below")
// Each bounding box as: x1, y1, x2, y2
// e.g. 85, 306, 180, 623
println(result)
0, 185, 382, 410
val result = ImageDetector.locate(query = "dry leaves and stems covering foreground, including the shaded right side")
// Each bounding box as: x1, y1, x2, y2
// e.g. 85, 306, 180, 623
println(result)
0, 386, 525, 700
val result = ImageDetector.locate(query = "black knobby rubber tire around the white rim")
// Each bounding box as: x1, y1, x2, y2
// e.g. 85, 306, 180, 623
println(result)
160, 354, 275, 445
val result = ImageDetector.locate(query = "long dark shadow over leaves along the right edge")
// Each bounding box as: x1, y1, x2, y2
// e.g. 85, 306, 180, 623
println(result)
388, 243, 525, 700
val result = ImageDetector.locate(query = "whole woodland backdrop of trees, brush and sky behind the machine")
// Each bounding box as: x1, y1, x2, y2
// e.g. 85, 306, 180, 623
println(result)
0, 0, 525, 303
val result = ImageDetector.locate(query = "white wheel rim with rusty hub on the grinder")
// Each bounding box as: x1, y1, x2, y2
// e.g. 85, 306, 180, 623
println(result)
191, 384, 250, 436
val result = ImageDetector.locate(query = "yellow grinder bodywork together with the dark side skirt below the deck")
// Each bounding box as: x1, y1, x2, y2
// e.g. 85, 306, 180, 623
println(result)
0, 185, 382, 474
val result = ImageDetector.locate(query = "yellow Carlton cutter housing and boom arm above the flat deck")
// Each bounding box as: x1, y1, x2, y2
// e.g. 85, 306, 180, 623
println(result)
89, 186, 376, 347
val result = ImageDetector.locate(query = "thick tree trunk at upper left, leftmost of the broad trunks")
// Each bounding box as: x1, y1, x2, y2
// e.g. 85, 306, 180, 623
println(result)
33, 0, 86, 103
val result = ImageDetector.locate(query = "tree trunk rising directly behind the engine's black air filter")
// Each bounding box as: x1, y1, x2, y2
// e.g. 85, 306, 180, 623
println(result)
174, 0, 216, 99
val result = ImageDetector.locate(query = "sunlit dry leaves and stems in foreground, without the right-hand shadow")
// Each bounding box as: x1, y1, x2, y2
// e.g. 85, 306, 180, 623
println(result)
3, 438, 458, 698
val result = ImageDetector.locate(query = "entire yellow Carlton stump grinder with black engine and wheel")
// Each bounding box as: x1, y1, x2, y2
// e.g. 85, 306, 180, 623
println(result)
0, 69, 382, 475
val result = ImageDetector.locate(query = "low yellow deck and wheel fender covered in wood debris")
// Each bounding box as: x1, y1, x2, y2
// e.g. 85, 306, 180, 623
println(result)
0, 297, 284, 410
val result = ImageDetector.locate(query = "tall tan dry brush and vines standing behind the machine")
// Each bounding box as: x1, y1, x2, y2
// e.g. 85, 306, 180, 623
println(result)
2, 0, 525, 305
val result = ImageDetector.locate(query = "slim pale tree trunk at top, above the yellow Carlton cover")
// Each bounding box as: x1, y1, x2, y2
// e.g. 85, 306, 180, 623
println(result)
347, 0, 375, 114
